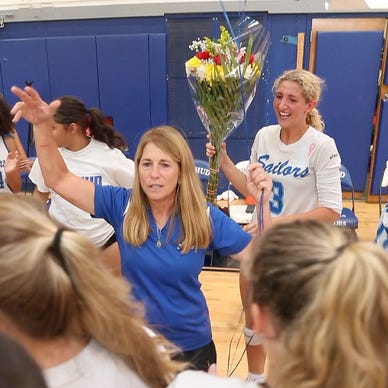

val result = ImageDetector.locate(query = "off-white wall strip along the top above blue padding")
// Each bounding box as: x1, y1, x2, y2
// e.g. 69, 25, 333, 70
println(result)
0, 0, 388, 22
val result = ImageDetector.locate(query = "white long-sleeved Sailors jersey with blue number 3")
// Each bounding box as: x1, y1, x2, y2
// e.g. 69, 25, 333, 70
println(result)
250, 125, 342, 217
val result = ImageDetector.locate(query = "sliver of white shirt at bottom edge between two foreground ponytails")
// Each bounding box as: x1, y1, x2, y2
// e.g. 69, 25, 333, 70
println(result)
168, 370, 260, 388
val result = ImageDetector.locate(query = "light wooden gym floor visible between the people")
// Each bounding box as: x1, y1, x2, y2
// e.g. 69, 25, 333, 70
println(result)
200, 200, 379, 379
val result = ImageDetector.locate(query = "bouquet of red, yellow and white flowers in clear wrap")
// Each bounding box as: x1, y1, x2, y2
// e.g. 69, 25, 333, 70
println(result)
185, 17, 270, 202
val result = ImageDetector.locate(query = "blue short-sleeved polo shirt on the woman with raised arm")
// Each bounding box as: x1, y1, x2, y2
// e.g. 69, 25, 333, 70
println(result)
94, 186, 251, 351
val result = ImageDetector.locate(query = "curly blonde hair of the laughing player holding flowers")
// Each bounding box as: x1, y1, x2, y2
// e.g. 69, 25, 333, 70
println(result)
272, 70, 325, 132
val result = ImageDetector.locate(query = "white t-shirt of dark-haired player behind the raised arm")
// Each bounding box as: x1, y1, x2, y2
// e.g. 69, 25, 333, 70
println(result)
29, 138, 135, 247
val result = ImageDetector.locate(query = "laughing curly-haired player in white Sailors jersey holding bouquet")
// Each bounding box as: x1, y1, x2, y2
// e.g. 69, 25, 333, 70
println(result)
206, 70, 342, 381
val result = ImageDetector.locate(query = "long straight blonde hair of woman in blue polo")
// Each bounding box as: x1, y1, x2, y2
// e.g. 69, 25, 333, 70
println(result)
123, 126, 211, 253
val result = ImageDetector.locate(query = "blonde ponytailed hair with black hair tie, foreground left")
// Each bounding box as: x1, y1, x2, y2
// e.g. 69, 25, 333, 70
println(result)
0, 194, 181, 388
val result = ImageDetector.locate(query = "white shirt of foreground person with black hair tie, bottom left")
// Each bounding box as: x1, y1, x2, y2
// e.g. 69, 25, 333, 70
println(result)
43, 340, 147, 388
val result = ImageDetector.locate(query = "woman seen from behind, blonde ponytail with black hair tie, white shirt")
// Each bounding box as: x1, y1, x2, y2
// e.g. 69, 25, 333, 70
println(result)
0, 193, 181, 388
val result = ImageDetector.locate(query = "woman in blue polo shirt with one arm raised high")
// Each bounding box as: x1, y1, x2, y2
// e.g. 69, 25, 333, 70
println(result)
12, 87, 272, 370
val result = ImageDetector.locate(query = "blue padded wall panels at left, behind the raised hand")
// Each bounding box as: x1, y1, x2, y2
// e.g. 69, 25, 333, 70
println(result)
0, 33, 168, 157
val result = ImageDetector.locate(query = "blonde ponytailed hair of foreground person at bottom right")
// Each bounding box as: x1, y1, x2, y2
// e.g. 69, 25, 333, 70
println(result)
251, 221, 388, 388
